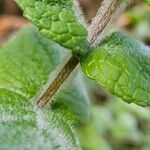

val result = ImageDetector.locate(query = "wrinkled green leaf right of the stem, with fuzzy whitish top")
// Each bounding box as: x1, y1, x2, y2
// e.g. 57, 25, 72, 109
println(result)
82, 32, 150, 106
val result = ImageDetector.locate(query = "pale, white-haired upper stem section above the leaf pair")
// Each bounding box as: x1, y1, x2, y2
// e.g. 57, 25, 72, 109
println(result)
88, 0, 131, 46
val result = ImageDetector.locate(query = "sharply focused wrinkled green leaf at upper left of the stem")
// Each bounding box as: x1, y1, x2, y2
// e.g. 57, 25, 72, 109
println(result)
16, 0, 87, 54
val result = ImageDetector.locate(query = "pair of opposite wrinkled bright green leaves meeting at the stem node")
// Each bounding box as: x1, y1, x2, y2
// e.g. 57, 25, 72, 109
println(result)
16, 0, 150, 106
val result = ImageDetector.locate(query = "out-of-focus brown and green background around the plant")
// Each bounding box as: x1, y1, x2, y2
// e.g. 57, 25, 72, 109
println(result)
0, 0, 150, 150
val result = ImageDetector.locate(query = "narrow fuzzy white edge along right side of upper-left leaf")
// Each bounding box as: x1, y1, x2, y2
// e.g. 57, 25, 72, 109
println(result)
73, 0, 88, 28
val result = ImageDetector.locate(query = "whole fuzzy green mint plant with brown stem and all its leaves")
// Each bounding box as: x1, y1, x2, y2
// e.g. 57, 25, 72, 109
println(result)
0, 0, 150, 150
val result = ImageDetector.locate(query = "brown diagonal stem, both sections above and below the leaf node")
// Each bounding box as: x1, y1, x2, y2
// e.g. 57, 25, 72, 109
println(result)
37, 0, 124, 108
